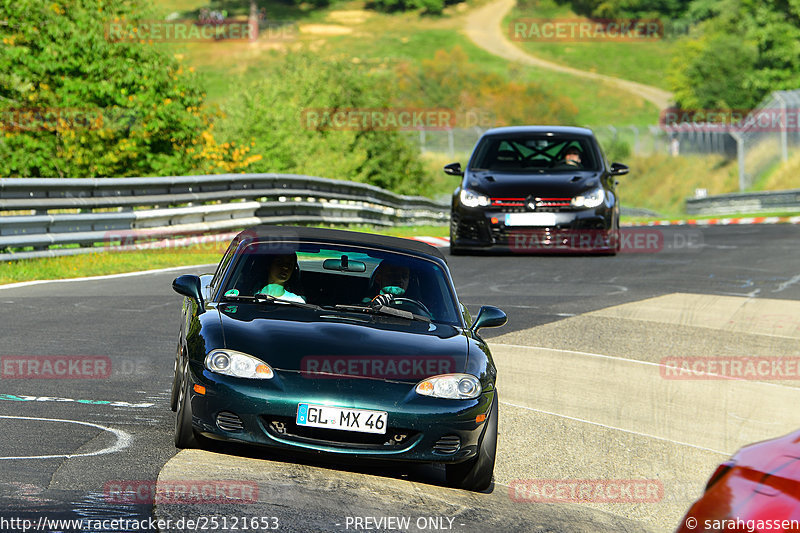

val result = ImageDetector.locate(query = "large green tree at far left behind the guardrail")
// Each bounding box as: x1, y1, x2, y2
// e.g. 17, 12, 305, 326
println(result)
0, 0, 244, 177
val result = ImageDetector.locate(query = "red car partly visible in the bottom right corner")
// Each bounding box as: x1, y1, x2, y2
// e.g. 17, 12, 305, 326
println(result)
677, 431, 800, 533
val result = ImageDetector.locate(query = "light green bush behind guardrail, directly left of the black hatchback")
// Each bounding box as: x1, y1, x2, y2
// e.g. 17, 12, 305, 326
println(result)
218, 51, 426, 194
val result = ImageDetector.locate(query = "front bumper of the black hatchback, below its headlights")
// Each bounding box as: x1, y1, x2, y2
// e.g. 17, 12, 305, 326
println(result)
450, 206, 618, 253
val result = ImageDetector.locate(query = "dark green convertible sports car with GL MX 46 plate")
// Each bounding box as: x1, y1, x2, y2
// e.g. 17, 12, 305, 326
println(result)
172, 226, 506, 490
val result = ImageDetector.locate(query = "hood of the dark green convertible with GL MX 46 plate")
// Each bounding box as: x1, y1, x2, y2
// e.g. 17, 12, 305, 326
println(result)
218, 305, 468, 382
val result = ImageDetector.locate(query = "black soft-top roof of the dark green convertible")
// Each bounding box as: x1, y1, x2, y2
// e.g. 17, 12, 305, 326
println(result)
237, 224, 447, 264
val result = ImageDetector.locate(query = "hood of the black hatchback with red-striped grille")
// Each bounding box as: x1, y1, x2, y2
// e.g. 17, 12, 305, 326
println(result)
466, 170, 600, 198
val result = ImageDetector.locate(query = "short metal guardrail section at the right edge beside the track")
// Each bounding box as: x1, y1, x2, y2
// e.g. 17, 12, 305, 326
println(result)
686, 189, 800, 215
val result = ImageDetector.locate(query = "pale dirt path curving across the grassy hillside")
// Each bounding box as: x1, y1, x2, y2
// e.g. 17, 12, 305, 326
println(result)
464, 0, 673, 110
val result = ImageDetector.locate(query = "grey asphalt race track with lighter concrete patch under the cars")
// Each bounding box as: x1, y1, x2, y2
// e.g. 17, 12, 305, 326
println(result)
0, 225, 800, 532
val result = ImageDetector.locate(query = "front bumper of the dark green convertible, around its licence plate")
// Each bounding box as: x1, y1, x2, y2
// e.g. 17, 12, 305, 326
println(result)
189, 364, 494, 463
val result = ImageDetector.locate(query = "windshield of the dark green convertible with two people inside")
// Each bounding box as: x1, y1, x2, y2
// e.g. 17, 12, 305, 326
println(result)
222, 242, 460, 325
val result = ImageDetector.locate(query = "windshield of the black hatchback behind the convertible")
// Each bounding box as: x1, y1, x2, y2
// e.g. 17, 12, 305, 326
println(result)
470, 134, 599, 172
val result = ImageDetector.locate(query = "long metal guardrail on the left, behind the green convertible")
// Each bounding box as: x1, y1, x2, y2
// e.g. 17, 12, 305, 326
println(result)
0, 174, 450, 261
